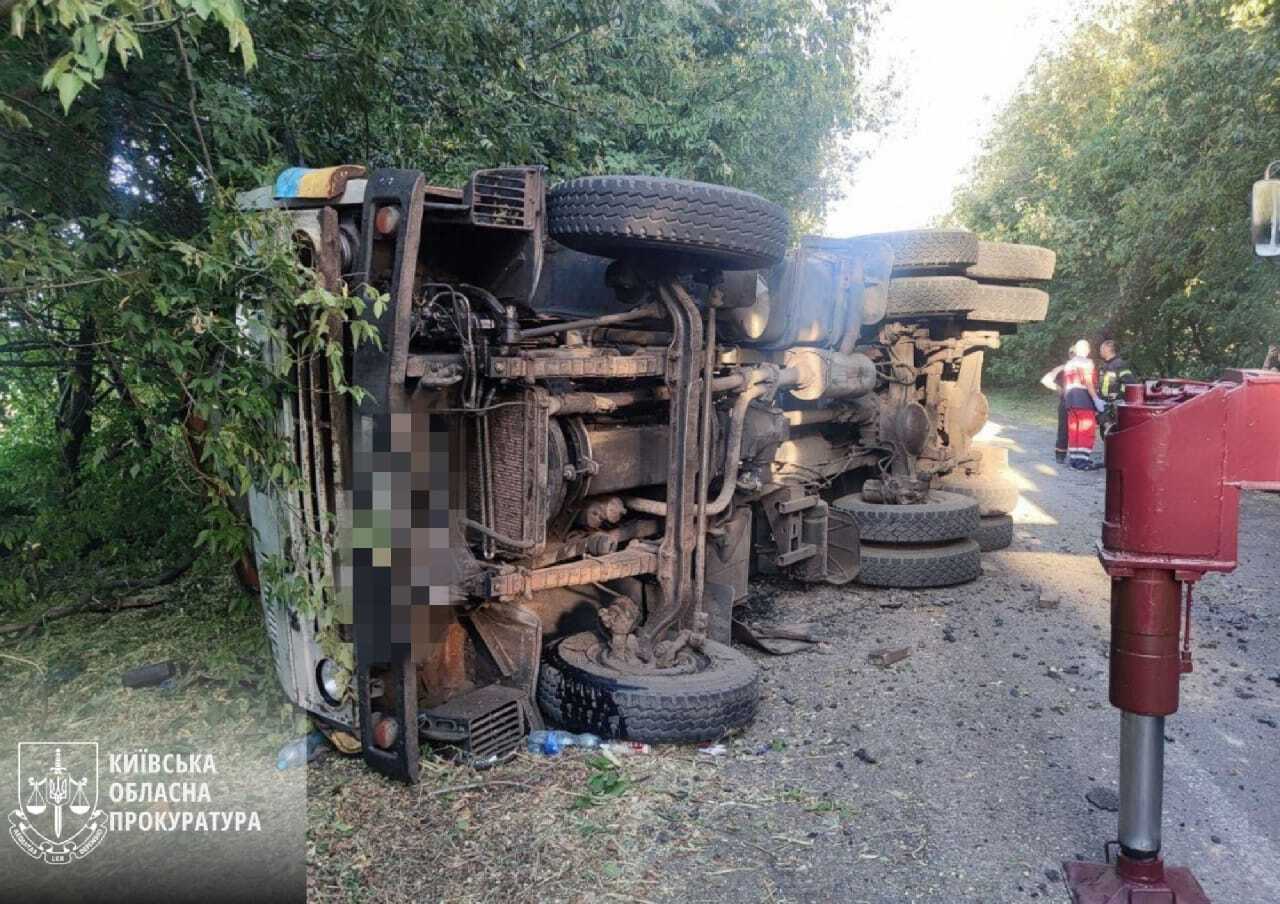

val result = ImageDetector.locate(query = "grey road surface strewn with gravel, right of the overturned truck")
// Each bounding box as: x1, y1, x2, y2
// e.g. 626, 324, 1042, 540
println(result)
653, 409, 1280, 904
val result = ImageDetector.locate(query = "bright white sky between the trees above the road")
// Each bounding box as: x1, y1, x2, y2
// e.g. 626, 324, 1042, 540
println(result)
826, 0, 1094, 236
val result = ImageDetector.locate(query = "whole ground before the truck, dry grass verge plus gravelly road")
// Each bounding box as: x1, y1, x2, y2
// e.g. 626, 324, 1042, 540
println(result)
307, 404, 1280, 904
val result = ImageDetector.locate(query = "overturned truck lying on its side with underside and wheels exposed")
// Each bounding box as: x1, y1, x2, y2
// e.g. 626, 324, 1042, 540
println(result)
246, 168, 1053, 780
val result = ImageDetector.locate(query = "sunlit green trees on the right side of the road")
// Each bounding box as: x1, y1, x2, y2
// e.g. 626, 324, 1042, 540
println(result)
951, 0, 1280, 383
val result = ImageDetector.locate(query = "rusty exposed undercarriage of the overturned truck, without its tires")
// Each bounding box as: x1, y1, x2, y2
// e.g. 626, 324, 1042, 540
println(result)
257, 158, 1049, 777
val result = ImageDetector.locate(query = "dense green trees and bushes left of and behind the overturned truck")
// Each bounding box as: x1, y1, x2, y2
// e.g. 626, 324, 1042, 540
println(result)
0, 0, 881, 612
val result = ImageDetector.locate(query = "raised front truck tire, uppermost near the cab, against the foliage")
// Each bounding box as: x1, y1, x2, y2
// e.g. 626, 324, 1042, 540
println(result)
547, 175, 788, 270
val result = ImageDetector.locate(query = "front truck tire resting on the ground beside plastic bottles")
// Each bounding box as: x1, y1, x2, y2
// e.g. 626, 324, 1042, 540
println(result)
538, 631, 760, 744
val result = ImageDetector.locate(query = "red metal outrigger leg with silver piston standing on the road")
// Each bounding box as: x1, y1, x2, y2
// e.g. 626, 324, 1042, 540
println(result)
1064, 370, 1280, 904
